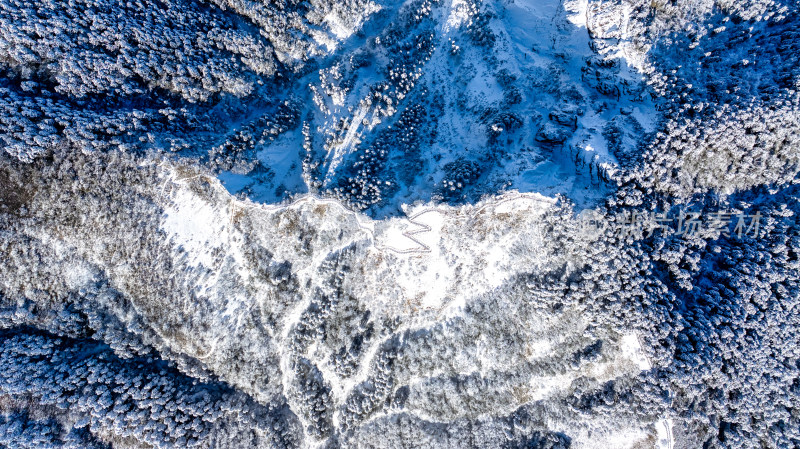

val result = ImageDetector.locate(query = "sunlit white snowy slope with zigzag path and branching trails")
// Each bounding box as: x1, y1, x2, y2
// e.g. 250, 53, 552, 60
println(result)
0, 156, 680, 448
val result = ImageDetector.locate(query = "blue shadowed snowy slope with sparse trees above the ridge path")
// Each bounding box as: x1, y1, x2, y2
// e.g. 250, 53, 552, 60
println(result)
211, 0, 658, 216
